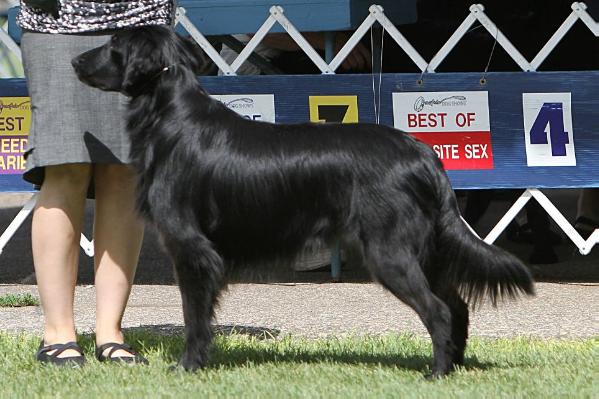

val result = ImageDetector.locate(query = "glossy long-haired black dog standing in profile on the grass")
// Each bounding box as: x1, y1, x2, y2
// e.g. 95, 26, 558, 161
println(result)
73, 27, 533, 375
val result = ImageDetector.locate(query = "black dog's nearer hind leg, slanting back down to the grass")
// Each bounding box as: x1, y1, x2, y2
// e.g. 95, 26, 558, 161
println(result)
366, 246, 455, 377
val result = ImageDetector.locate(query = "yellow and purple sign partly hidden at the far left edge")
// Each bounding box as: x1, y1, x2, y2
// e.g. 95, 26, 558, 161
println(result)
0, 97, 31, 175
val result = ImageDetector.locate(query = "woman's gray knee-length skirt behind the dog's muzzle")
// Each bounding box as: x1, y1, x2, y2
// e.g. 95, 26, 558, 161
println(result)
21, 32, 129, 185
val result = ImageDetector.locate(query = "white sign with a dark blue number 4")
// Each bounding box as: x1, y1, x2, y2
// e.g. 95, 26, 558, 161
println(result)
522, 93, 576, 166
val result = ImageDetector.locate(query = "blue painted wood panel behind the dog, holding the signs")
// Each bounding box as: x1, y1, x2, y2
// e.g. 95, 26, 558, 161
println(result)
0, 71, 599, 191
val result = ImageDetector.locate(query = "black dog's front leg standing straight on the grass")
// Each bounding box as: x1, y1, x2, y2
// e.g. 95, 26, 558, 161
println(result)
163, 232, 224, 371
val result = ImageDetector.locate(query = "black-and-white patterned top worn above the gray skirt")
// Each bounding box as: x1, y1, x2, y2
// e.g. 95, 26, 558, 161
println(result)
17, 0, 175, 33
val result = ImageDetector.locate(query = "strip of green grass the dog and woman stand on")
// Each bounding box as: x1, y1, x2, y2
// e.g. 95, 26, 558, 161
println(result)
0, 331, 599, 399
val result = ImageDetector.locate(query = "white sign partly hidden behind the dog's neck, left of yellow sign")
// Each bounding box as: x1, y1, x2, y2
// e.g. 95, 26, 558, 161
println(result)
212, 94, 275, 123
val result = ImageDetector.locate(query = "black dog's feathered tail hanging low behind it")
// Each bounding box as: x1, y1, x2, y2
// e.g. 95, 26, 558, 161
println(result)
437, 182, 534, 306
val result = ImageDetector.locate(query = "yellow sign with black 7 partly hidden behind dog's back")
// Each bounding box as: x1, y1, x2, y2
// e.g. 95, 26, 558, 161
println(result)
309, 96, 358, 123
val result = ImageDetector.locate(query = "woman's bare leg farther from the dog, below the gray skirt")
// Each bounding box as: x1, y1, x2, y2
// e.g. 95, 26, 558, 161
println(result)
31, 164, 91, 357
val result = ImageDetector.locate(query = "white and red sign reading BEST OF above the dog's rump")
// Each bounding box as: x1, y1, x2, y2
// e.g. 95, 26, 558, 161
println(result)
393, 91, 493, 170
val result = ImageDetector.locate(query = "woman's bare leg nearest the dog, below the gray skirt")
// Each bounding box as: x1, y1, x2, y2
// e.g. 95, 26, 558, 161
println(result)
94, 164, 143, 357
